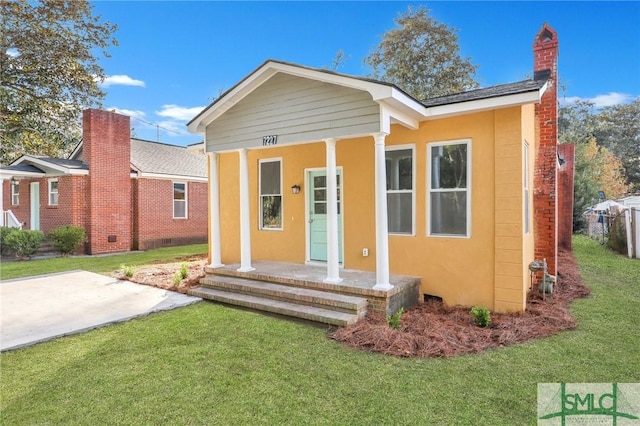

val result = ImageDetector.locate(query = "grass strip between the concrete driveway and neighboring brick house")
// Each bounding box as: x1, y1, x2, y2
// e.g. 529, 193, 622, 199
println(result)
0, 244, 207, 280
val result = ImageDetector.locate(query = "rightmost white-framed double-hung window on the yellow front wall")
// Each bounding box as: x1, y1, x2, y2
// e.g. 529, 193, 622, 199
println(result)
427, 140, 471, 237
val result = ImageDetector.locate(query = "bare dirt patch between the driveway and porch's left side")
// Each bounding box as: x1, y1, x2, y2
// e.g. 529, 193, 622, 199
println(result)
111, 255, 207, 293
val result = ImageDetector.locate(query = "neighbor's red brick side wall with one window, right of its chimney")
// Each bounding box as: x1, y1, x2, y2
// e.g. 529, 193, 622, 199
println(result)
132, 179, 207, 250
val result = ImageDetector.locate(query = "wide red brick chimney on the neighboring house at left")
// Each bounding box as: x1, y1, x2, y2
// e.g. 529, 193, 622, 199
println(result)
82, 109, 131, 254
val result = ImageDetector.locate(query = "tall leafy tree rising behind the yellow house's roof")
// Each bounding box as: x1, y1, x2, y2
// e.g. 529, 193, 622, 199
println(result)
364, 6, 478, 100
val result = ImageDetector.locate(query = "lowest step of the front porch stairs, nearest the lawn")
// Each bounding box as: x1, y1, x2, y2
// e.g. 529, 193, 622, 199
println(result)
189, 286, 364, 326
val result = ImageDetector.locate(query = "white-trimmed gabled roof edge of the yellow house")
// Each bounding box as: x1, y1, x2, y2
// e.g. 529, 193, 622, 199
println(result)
187, 59, 547, 133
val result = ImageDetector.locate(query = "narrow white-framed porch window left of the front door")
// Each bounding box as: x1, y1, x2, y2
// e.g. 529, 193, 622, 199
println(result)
259, 159, 282, 229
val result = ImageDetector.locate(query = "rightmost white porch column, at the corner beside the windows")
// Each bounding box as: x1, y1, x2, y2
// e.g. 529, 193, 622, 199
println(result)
373, 133, 393, 290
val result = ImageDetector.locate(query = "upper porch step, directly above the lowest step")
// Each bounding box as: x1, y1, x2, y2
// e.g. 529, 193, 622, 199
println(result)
200, 275, 368, 315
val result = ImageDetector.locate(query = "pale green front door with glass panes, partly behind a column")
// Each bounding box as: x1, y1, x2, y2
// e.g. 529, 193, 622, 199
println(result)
307, 170, 342, 263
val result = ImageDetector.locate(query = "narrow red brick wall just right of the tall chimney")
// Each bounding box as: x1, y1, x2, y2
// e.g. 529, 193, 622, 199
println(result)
558, 144, 575, 250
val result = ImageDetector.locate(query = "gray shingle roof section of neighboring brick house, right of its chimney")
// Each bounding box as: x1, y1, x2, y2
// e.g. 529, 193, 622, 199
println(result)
131, 139, 207, 178
